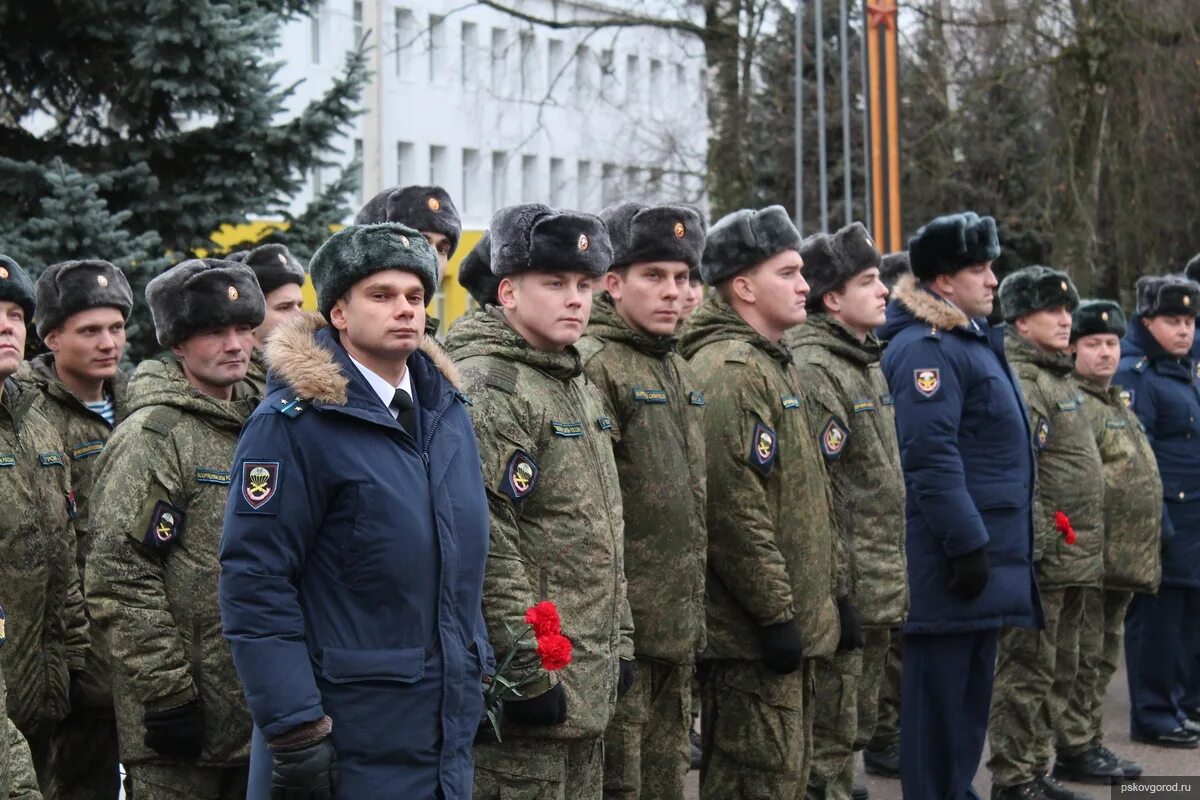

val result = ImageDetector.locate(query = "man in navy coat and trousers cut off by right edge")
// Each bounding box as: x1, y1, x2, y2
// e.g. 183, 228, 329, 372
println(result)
1114, 276, 1200, 748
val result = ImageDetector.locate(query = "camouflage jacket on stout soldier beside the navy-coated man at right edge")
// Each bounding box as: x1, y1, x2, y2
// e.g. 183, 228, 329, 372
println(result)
1076, 375, 1163, 593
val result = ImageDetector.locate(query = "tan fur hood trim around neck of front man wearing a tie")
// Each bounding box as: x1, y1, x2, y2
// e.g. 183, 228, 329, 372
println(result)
265, 313, 462, 405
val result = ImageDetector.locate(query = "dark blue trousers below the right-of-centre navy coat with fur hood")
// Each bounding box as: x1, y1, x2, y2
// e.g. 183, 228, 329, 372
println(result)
900, 630, 998, 800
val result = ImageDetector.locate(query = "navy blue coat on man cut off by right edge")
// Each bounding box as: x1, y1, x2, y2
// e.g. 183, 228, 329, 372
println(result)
1112, 314, 1200, 587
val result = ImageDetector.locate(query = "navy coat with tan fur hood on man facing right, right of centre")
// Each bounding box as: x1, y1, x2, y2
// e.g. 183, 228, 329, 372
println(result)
882, 278, 1042, 633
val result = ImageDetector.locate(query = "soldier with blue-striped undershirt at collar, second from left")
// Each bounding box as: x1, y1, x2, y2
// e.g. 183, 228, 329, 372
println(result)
17, 260, 133, 800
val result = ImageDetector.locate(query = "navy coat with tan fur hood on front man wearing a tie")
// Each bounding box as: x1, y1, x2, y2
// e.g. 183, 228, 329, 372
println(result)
220, 318, 492, 800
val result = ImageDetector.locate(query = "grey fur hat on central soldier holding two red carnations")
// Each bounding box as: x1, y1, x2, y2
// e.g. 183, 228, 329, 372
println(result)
488, 203, 612, 278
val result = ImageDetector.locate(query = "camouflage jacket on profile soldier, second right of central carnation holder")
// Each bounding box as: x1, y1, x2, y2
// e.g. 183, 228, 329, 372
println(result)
680, 296, 839, 661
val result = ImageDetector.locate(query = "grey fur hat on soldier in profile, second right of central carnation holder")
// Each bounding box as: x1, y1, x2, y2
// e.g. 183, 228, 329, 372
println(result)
700, 205, 800, 287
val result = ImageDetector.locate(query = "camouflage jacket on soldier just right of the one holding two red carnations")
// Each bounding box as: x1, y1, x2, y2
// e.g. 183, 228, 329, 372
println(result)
578, 294, 708, 664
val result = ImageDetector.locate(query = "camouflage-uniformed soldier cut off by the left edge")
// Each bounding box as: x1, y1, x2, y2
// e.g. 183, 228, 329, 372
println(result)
0, 255, 88, 787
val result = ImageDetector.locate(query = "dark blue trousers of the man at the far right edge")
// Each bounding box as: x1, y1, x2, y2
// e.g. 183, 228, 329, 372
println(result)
1126, 587, 1200, 736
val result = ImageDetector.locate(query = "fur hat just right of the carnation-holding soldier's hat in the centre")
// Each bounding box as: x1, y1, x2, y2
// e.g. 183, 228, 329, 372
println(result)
600, 203, 708, 269
